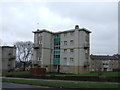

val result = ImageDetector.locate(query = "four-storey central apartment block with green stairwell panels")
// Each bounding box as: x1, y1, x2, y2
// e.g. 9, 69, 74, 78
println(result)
32, 25, 91, 74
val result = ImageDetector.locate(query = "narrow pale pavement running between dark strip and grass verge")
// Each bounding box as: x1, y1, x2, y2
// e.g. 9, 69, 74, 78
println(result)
0, 77, 120, 84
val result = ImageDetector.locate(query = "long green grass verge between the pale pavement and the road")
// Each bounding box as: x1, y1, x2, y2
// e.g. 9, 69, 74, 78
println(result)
3, 79, 120, 88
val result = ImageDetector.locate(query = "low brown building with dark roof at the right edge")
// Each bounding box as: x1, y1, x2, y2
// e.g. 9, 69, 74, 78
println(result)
90, 54, 120, 71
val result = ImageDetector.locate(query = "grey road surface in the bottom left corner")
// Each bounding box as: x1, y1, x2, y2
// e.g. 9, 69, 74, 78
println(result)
2, 82, 71, 90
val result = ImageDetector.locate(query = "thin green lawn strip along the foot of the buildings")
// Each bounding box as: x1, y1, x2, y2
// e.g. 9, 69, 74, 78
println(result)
3, 71, 120, 76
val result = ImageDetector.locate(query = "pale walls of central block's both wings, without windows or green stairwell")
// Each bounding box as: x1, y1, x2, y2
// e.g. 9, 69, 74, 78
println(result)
33, 29, 89, 74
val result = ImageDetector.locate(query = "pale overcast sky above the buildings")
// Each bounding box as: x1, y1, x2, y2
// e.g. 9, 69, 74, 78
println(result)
0, 2, 118, 55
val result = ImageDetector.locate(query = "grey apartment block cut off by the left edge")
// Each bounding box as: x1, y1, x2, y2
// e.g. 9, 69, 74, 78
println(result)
0, 46, 16, 73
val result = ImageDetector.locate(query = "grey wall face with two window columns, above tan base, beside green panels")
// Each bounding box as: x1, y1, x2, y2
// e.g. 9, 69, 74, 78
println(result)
60, 32, 76, 66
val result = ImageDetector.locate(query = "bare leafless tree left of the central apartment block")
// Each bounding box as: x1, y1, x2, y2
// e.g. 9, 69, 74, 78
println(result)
14, 41, 33, 71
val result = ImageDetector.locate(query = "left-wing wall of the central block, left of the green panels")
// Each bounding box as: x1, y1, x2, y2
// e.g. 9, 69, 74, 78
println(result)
32, 32, 54, 71
